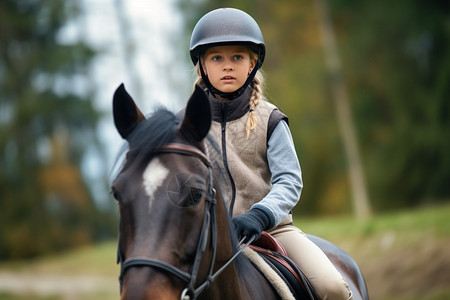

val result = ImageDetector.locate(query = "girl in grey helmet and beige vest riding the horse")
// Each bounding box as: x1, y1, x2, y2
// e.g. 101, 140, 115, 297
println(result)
190, 8, 352, 299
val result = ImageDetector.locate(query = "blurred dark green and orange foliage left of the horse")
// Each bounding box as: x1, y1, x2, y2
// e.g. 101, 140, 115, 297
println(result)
0, 0, 116, 259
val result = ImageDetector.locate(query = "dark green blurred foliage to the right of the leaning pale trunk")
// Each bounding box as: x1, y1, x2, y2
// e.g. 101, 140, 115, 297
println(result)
334, 1, 450, 208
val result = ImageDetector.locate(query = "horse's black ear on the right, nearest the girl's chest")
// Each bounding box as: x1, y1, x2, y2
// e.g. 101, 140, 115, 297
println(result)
180, 86, 211, 142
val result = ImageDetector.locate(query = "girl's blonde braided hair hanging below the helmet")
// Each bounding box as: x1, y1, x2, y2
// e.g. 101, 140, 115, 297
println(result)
194, 49, 265, 139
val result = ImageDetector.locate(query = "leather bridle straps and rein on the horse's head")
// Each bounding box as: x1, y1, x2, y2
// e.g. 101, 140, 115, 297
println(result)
117, 143, 252, 300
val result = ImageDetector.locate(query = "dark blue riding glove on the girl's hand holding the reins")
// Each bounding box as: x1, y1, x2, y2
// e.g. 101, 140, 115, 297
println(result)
232, 208, 270, 240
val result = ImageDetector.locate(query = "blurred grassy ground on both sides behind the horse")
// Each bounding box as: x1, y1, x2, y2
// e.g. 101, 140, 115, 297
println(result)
0, 204, 450, 300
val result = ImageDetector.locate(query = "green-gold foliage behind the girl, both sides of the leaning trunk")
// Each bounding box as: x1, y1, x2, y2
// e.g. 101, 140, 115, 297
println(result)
181, 0, 450, 214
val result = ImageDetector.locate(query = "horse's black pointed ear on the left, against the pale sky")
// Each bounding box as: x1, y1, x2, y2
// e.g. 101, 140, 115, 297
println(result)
113, 83, 145, 139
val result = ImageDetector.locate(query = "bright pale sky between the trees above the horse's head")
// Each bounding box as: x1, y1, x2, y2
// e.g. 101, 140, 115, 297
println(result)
65, 0, 193, 205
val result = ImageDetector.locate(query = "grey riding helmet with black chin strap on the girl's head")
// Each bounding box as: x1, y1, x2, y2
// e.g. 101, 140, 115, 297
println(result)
190, 8, 266, 99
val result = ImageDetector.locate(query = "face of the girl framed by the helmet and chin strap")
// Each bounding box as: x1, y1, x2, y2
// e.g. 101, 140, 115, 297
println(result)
203, 45, 257, 93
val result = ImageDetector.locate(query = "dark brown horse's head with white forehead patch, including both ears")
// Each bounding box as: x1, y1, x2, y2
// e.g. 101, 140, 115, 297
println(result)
112, 85, 225, 299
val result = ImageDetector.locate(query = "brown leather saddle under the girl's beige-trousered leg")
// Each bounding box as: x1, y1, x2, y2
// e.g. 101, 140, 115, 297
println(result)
249, 231, 318, 300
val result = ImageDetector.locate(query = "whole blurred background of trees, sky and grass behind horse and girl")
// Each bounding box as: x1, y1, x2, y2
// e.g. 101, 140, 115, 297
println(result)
0, 0, 450, 299
